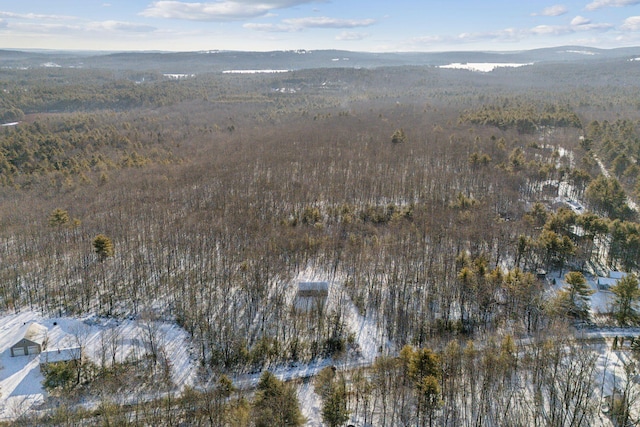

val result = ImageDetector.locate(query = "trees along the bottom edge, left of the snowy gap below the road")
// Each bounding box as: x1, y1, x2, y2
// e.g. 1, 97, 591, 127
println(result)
19, 371, 305, 427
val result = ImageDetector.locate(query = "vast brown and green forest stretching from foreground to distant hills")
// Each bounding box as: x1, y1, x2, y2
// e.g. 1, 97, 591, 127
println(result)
0, 51, 640, 426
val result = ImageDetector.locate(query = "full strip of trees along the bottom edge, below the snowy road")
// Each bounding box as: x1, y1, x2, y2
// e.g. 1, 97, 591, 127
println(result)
22, 330, 616, 427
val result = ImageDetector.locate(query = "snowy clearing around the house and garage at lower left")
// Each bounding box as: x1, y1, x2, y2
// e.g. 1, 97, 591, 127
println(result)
0, 311, 197, 422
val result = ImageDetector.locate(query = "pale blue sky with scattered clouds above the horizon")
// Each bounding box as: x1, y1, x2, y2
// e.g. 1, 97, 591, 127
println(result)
0, 0, 640, 52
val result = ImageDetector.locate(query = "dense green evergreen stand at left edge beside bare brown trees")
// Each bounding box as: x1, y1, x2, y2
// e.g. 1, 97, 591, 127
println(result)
0, 113, 177, 190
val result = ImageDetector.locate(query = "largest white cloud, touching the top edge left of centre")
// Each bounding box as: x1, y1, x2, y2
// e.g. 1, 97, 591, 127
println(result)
140, 0, 317, 21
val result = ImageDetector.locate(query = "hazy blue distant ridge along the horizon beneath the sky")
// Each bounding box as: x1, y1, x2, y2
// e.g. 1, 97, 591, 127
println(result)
0, 46, 640, 73
